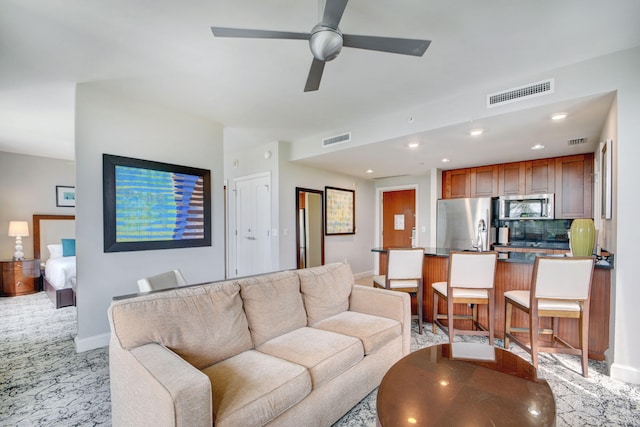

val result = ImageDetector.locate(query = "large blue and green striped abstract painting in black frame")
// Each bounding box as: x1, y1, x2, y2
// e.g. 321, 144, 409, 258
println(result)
102, 154, 211, 252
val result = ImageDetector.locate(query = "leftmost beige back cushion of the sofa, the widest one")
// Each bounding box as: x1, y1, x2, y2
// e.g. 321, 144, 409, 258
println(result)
109, 282, 253, 369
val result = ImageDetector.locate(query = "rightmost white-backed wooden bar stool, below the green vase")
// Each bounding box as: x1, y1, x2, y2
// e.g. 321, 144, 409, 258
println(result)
504, 257, 595, 378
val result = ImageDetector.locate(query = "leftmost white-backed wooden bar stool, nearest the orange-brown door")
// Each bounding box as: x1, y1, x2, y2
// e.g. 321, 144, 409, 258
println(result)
373, 248, 424, 334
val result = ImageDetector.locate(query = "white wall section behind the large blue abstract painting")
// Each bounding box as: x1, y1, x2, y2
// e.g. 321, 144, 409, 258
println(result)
75, 84, 224, 351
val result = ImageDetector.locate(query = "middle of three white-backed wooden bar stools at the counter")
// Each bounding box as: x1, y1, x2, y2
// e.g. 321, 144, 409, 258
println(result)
431, 251, 498, 345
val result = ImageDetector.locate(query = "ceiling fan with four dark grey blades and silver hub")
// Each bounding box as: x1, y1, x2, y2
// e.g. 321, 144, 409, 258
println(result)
211, 0, 431, 92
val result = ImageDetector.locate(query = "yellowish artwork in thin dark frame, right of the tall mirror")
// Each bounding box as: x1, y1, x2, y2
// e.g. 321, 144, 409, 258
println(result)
324, 187, 356, 235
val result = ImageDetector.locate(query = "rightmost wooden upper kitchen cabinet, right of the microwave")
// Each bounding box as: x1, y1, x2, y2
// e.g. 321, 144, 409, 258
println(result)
555, 153, 593, 219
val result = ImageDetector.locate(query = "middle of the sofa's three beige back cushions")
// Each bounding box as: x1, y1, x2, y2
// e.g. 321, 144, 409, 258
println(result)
238, 271, 307, 347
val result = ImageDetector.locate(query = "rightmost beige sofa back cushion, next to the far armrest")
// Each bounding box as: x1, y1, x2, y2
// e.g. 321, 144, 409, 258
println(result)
297, 263, 353, 326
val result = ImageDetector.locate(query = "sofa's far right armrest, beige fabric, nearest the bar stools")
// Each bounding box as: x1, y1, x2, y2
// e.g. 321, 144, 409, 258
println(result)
349, 285, 411, 355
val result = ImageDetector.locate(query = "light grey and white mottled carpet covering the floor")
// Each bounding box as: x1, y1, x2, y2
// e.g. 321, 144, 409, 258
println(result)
0, 292, 640, 427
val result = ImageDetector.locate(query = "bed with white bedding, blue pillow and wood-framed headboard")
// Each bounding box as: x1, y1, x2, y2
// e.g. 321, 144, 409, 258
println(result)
33, 215, 76, 308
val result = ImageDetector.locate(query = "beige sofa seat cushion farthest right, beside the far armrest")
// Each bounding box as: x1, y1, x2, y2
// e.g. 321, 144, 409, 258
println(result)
312, 311, 402, 355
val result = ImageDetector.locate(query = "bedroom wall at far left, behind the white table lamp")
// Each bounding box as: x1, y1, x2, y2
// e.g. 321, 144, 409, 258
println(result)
0, 152, 76, 259
